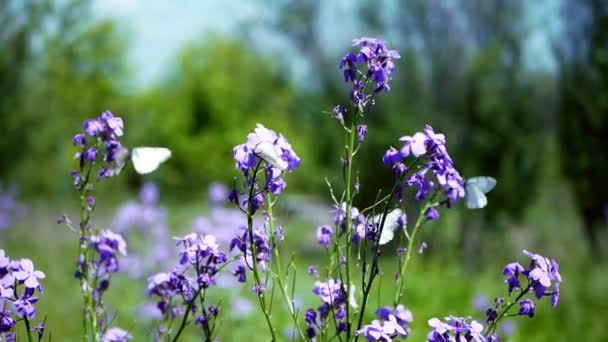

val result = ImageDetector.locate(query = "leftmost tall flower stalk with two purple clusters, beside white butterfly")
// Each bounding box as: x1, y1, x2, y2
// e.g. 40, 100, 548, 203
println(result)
69, 112, 128, 341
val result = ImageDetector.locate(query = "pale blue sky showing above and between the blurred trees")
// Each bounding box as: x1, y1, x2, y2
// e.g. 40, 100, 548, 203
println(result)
93, 0, 560, 86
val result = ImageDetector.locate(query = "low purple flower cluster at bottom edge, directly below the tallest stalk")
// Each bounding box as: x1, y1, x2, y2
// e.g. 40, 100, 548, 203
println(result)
356, 304, 414, 341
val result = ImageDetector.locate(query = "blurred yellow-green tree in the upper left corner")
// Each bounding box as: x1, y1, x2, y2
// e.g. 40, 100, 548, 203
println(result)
2, 0, 126, 193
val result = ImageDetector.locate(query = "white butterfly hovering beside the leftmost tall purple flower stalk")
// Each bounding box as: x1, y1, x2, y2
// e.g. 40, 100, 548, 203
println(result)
110, 147, 171, 175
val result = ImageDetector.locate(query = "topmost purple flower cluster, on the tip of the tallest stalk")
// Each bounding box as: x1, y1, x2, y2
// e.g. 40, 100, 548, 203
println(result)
339, 38, 401, 106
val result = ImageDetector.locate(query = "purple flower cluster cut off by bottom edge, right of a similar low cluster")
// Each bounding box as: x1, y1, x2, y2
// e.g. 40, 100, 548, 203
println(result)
426, 316, 486, 342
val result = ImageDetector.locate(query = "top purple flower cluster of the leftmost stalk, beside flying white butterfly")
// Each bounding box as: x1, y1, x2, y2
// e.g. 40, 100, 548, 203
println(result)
72, 111, 128, 187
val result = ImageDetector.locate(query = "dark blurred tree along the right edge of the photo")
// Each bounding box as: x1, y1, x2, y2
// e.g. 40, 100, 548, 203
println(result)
557, 0, 608, 255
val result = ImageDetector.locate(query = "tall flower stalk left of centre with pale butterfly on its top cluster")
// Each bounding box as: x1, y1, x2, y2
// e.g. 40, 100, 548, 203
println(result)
230, 124, 303, 341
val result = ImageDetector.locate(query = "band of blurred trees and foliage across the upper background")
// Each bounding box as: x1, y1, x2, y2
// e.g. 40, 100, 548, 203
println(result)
0, 0, 608, 251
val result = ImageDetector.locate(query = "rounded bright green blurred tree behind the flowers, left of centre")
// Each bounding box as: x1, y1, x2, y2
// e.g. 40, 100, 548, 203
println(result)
139, 38, 312, 194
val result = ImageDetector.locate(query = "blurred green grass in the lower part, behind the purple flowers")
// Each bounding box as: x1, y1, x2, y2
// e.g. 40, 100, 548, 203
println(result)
0, 194, 608, 342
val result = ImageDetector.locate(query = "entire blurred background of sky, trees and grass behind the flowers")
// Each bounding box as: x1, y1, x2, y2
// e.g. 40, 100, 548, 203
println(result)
0, 0, 608, 341
